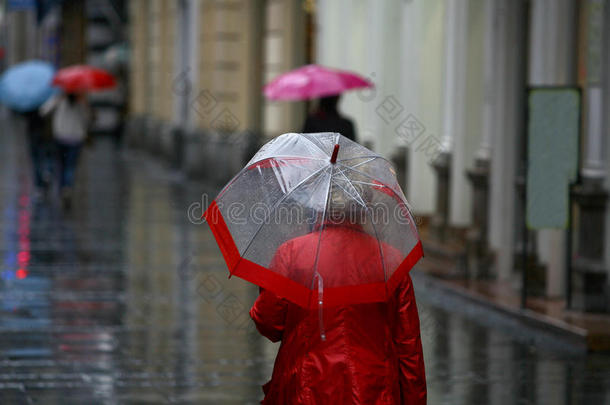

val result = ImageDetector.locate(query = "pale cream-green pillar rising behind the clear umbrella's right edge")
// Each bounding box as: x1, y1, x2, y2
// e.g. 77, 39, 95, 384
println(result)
404, 1, 448, 216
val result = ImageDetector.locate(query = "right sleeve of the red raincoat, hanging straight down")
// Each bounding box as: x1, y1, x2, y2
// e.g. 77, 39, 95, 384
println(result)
394, 275, 427, 405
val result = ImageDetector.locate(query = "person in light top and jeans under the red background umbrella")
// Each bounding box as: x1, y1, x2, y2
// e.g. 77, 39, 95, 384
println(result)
40, 93, 90, 208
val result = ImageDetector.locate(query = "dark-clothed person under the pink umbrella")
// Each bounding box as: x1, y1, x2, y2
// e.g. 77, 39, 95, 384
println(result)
303, 95, 357, 142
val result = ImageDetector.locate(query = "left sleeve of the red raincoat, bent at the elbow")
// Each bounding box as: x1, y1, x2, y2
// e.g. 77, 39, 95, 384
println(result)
250, 248, 289, 342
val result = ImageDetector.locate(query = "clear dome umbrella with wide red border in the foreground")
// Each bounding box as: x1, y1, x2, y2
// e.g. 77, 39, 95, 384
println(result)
204, 133, 423, 309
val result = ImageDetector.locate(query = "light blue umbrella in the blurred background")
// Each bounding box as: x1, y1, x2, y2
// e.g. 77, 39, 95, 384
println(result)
0, 60, 57, 112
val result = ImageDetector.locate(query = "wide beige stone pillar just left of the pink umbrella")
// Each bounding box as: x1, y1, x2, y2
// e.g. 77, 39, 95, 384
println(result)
197, 0, 263, 134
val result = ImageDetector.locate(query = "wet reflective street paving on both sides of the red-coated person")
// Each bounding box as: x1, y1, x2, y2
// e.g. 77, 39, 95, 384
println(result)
0, 115, 610, 405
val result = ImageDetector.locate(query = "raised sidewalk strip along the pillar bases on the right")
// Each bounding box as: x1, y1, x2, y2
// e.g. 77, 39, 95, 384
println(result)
414, 232, 610, 352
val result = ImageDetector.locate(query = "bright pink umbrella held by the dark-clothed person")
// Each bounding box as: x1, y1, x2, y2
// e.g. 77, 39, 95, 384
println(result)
264, 65, 373, 100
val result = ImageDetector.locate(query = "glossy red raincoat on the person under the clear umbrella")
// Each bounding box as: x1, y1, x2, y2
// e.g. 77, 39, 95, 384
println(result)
250, 226, 426, 405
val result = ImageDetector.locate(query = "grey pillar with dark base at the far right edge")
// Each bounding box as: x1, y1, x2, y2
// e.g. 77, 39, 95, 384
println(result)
569, 0, 610, 312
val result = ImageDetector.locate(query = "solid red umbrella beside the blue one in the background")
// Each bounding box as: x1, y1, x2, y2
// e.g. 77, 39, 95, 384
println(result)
53, 65, 116, 93
